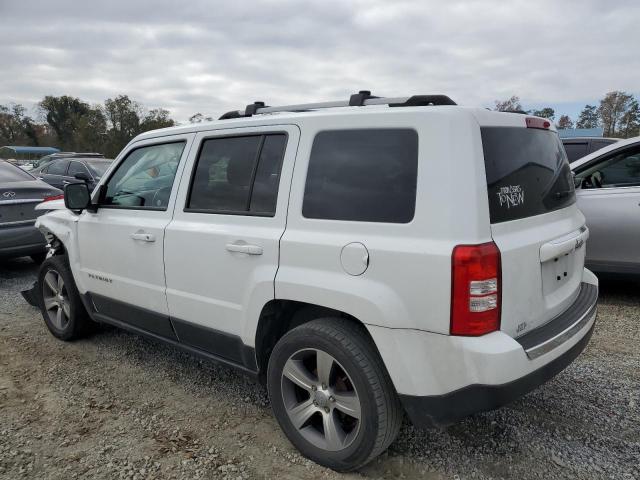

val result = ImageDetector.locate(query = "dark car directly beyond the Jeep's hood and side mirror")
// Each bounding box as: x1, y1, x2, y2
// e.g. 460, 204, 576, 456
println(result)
31, 157, 113, 190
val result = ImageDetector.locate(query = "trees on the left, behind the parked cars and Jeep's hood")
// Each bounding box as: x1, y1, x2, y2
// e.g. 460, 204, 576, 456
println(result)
0, 95, 176, 158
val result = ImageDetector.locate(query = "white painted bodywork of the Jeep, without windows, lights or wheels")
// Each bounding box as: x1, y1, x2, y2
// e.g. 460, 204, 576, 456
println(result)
33, 106, 596, 402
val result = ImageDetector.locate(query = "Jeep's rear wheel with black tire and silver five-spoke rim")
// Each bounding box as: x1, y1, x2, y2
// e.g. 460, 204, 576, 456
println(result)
267, 318, 403, 472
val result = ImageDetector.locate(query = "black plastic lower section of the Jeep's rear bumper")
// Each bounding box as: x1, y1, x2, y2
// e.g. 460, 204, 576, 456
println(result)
400, 313, 595, 427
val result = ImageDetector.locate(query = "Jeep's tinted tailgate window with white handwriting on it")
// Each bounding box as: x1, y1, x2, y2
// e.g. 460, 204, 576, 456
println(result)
480, 127, 576, 223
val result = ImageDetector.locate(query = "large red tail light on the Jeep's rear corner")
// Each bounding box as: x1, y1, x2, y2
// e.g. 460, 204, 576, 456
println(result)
450, 242, 502, 336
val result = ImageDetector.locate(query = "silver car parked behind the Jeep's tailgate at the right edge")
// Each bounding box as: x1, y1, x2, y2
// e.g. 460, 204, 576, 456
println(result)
571, 137, 640, 275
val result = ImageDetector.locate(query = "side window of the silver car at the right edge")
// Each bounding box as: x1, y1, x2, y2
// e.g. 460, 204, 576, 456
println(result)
576, 147, 640, 188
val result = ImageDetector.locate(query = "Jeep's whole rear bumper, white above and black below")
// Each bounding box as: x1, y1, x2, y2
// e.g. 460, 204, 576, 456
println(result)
367, 269, 598, 426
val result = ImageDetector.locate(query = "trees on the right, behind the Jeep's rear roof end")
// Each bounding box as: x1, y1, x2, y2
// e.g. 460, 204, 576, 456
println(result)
494, 91, 640, 138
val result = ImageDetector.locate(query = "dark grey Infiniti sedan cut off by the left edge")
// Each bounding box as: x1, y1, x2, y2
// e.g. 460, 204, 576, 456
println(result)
0, 160, 62, 262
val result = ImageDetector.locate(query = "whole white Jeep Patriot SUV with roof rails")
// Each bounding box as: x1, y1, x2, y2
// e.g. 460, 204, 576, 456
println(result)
34, 91, 598, 471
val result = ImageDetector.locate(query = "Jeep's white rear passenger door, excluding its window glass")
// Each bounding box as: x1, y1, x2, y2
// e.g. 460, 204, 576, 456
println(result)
165, 125, 300, 346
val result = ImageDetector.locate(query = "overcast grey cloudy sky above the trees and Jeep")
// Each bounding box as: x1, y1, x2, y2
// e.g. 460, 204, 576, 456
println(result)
0, 0, 640, 121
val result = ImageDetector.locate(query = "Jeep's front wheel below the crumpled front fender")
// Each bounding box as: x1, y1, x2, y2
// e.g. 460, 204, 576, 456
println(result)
38, 255, 95, 341
